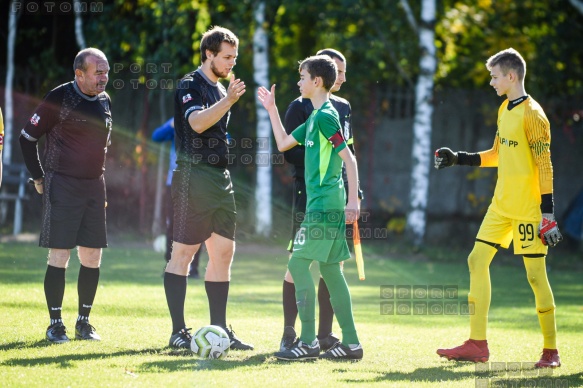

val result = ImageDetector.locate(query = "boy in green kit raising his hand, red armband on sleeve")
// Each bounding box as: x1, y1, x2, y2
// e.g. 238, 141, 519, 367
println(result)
257, 55, 363, 360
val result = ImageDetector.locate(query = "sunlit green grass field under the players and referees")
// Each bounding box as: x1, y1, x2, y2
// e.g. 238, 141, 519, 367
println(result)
0, 242, 583, 387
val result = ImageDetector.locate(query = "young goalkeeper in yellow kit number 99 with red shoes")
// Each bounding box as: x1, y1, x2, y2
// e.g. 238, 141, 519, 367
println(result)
435, 48, 562, 368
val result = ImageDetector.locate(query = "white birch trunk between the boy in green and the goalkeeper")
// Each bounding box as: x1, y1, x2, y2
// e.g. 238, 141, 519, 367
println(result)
407, 0, 436, 247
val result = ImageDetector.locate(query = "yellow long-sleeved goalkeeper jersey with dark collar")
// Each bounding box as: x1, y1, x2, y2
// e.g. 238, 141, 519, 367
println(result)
480, 96, 553, 221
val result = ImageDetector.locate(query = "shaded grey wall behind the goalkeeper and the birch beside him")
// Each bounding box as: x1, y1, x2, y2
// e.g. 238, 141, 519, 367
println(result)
355, 90, 583, 242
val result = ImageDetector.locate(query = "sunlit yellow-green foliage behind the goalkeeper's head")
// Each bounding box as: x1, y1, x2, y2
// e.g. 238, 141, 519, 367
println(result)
436, 0, 583, 98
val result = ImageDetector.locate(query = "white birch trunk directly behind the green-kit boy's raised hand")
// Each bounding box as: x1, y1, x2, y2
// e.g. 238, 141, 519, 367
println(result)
253, 1, 272, 237
